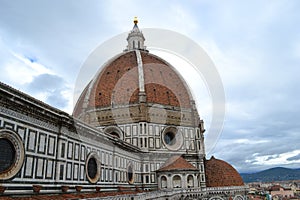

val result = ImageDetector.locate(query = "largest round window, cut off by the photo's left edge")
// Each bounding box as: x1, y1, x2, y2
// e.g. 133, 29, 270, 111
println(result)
0, 130, 24, 180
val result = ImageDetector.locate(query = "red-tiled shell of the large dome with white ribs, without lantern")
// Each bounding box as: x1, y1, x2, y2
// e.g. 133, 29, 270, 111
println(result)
73, 51, 192, 117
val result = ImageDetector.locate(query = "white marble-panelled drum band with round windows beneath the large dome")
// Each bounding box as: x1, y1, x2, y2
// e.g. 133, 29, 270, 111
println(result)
119, 122, 204, 154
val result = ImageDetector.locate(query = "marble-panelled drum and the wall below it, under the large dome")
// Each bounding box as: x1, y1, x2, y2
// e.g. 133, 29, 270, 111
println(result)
102, 122, 205, 191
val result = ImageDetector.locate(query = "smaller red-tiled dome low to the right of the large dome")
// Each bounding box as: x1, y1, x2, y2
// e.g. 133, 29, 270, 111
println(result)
205, 156, 244, 187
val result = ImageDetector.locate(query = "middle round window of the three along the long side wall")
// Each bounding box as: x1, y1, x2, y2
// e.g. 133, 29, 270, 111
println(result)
85, 152, 100, 183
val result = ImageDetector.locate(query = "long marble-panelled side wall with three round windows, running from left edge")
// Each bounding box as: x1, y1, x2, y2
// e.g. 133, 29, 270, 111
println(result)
0, 85, 143, 194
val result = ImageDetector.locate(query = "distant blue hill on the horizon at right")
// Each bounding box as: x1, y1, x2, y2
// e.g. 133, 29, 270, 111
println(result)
241, 167, 300, 183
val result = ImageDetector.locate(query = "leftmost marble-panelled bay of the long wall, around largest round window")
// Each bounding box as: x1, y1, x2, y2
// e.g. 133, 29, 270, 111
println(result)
0, 107, 58, 183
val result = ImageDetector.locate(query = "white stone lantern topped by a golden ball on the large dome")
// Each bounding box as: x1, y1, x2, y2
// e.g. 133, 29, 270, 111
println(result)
126, 17, 146, 51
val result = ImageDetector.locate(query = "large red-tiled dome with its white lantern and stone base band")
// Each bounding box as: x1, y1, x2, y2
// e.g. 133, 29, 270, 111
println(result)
73, 19, 199, 126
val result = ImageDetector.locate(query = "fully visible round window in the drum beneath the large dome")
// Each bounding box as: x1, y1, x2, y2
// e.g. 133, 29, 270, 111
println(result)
162, 126, 183, 150
